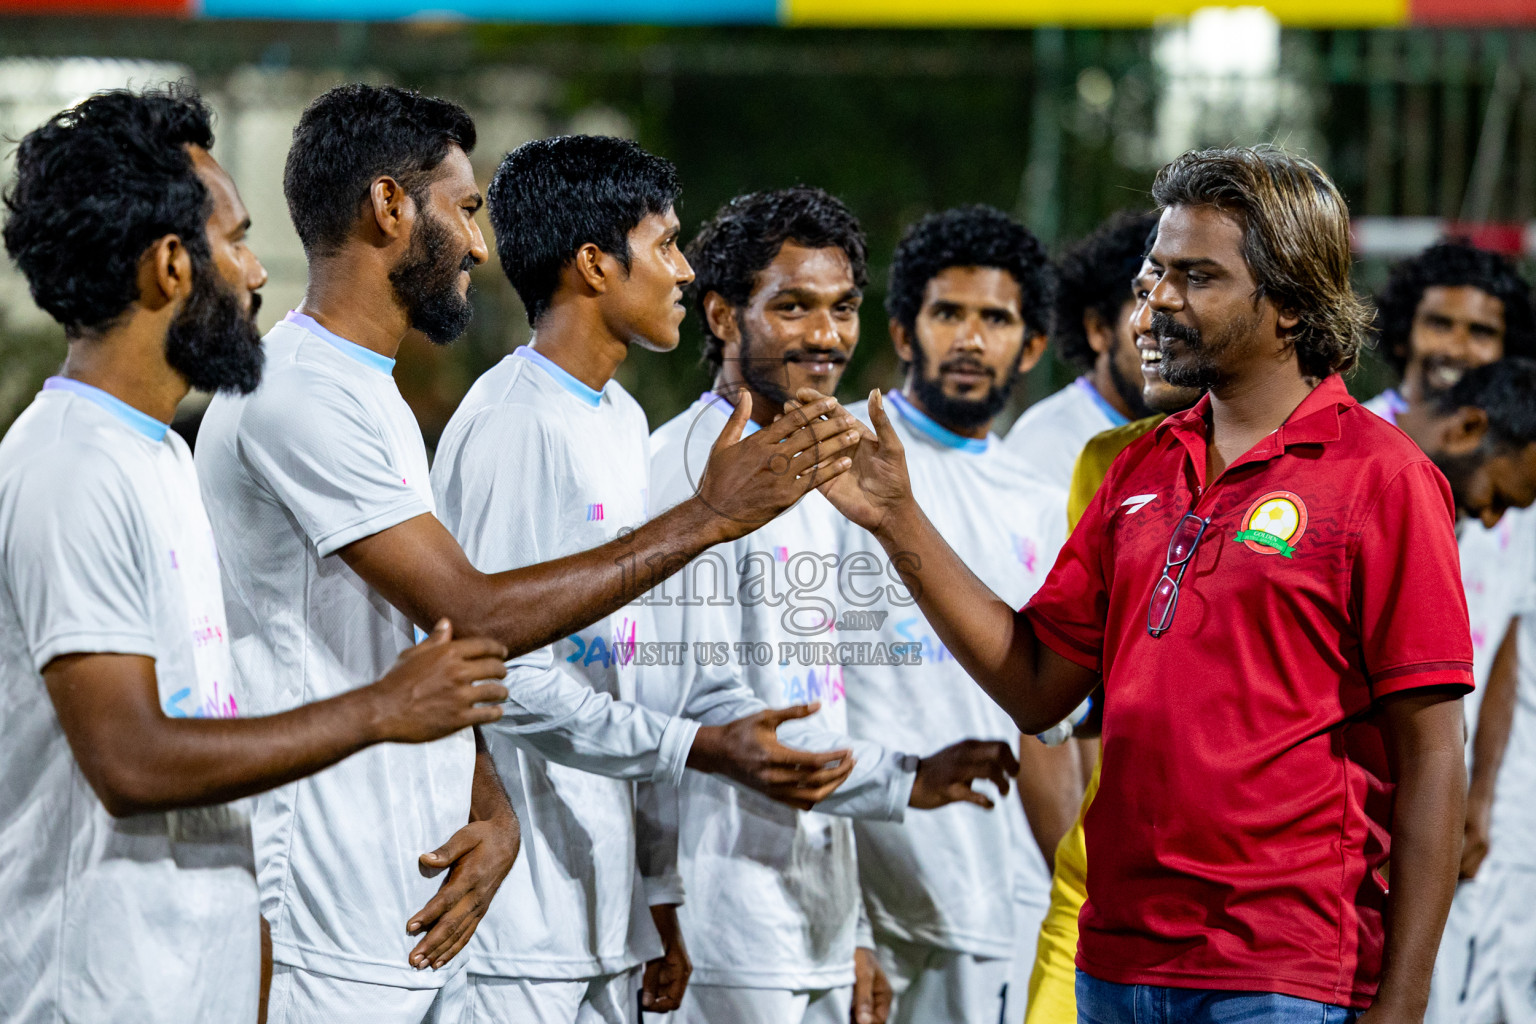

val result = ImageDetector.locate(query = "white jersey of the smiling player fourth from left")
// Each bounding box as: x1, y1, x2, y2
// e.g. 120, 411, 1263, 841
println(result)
641, 395, 917, 989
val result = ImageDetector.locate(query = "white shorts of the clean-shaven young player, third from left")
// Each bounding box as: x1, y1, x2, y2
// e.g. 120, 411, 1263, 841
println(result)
460, 967, 641, 1024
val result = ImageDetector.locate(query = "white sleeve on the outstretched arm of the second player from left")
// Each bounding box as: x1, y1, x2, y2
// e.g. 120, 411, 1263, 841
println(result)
238, 376, 430, 557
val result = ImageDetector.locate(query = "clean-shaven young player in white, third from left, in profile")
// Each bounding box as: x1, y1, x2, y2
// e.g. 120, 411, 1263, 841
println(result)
432, 144, 903, 1024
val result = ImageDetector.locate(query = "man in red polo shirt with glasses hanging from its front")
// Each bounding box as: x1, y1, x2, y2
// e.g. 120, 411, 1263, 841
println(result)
826, 147, 1471, 1024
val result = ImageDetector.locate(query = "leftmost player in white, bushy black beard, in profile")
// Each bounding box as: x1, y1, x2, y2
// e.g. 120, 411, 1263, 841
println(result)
0, 88, 505, 1024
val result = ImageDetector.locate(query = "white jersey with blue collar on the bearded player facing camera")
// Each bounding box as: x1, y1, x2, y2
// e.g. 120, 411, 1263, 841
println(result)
845, 391, 1066, 956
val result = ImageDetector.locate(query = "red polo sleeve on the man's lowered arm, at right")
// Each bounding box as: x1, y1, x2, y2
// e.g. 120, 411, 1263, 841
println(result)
1352, 462, 1473, 697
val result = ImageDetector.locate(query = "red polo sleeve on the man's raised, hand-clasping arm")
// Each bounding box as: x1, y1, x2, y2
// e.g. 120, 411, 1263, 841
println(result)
1023, 463, 1109, 672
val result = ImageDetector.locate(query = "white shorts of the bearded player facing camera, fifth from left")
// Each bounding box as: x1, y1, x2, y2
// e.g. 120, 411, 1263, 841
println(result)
874, 929, 1007, 1024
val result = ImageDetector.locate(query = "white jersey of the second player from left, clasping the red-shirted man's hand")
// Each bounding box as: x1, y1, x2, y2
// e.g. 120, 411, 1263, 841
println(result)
197, 313, 475, 989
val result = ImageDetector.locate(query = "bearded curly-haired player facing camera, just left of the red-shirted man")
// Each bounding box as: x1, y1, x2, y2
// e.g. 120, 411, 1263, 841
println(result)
845, 206, 1081, 1024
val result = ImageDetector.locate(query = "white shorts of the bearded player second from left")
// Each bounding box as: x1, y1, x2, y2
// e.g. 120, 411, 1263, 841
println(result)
267, 964, 464, 1024
